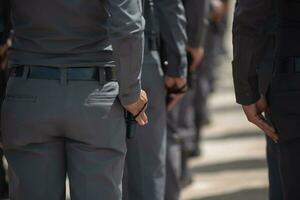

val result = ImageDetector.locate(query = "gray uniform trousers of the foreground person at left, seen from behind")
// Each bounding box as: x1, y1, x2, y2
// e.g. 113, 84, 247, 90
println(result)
1, 70, 126, 200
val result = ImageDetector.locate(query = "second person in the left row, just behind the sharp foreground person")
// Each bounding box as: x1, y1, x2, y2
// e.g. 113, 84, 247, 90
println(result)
123, 0, 187, 200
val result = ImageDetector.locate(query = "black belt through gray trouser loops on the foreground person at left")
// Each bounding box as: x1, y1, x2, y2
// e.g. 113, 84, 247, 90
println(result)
10, 66, 117, 83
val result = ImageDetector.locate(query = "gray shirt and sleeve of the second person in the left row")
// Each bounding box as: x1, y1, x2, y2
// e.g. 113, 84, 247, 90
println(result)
144, 0, 187, 77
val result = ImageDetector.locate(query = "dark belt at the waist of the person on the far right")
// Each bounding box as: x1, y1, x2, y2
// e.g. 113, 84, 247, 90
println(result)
275, 57, 300, 74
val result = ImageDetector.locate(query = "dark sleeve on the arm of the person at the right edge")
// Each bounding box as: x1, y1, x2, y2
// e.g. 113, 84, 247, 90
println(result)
233, 0, 271, 105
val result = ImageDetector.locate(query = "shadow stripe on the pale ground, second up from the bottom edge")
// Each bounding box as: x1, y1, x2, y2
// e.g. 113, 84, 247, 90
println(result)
191, 159, 267, 173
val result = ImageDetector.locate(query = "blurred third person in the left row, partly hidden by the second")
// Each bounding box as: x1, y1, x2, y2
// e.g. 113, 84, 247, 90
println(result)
165, 0, 208, 200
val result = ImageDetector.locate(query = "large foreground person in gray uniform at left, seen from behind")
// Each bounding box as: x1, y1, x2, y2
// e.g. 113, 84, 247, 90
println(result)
0, 0, 147, 200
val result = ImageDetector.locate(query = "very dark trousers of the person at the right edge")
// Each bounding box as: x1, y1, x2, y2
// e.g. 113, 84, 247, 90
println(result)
268, 72, 300, 200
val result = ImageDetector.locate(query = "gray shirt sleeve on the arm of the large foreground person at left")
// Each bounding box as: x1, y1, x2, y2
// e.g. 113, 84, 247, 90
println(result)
108, 0, 144, 106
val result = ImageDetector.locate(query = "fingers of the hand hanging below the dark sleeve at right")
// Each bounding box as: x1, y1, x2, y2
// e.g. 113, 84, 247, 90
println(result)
249, 115, 279, 143
